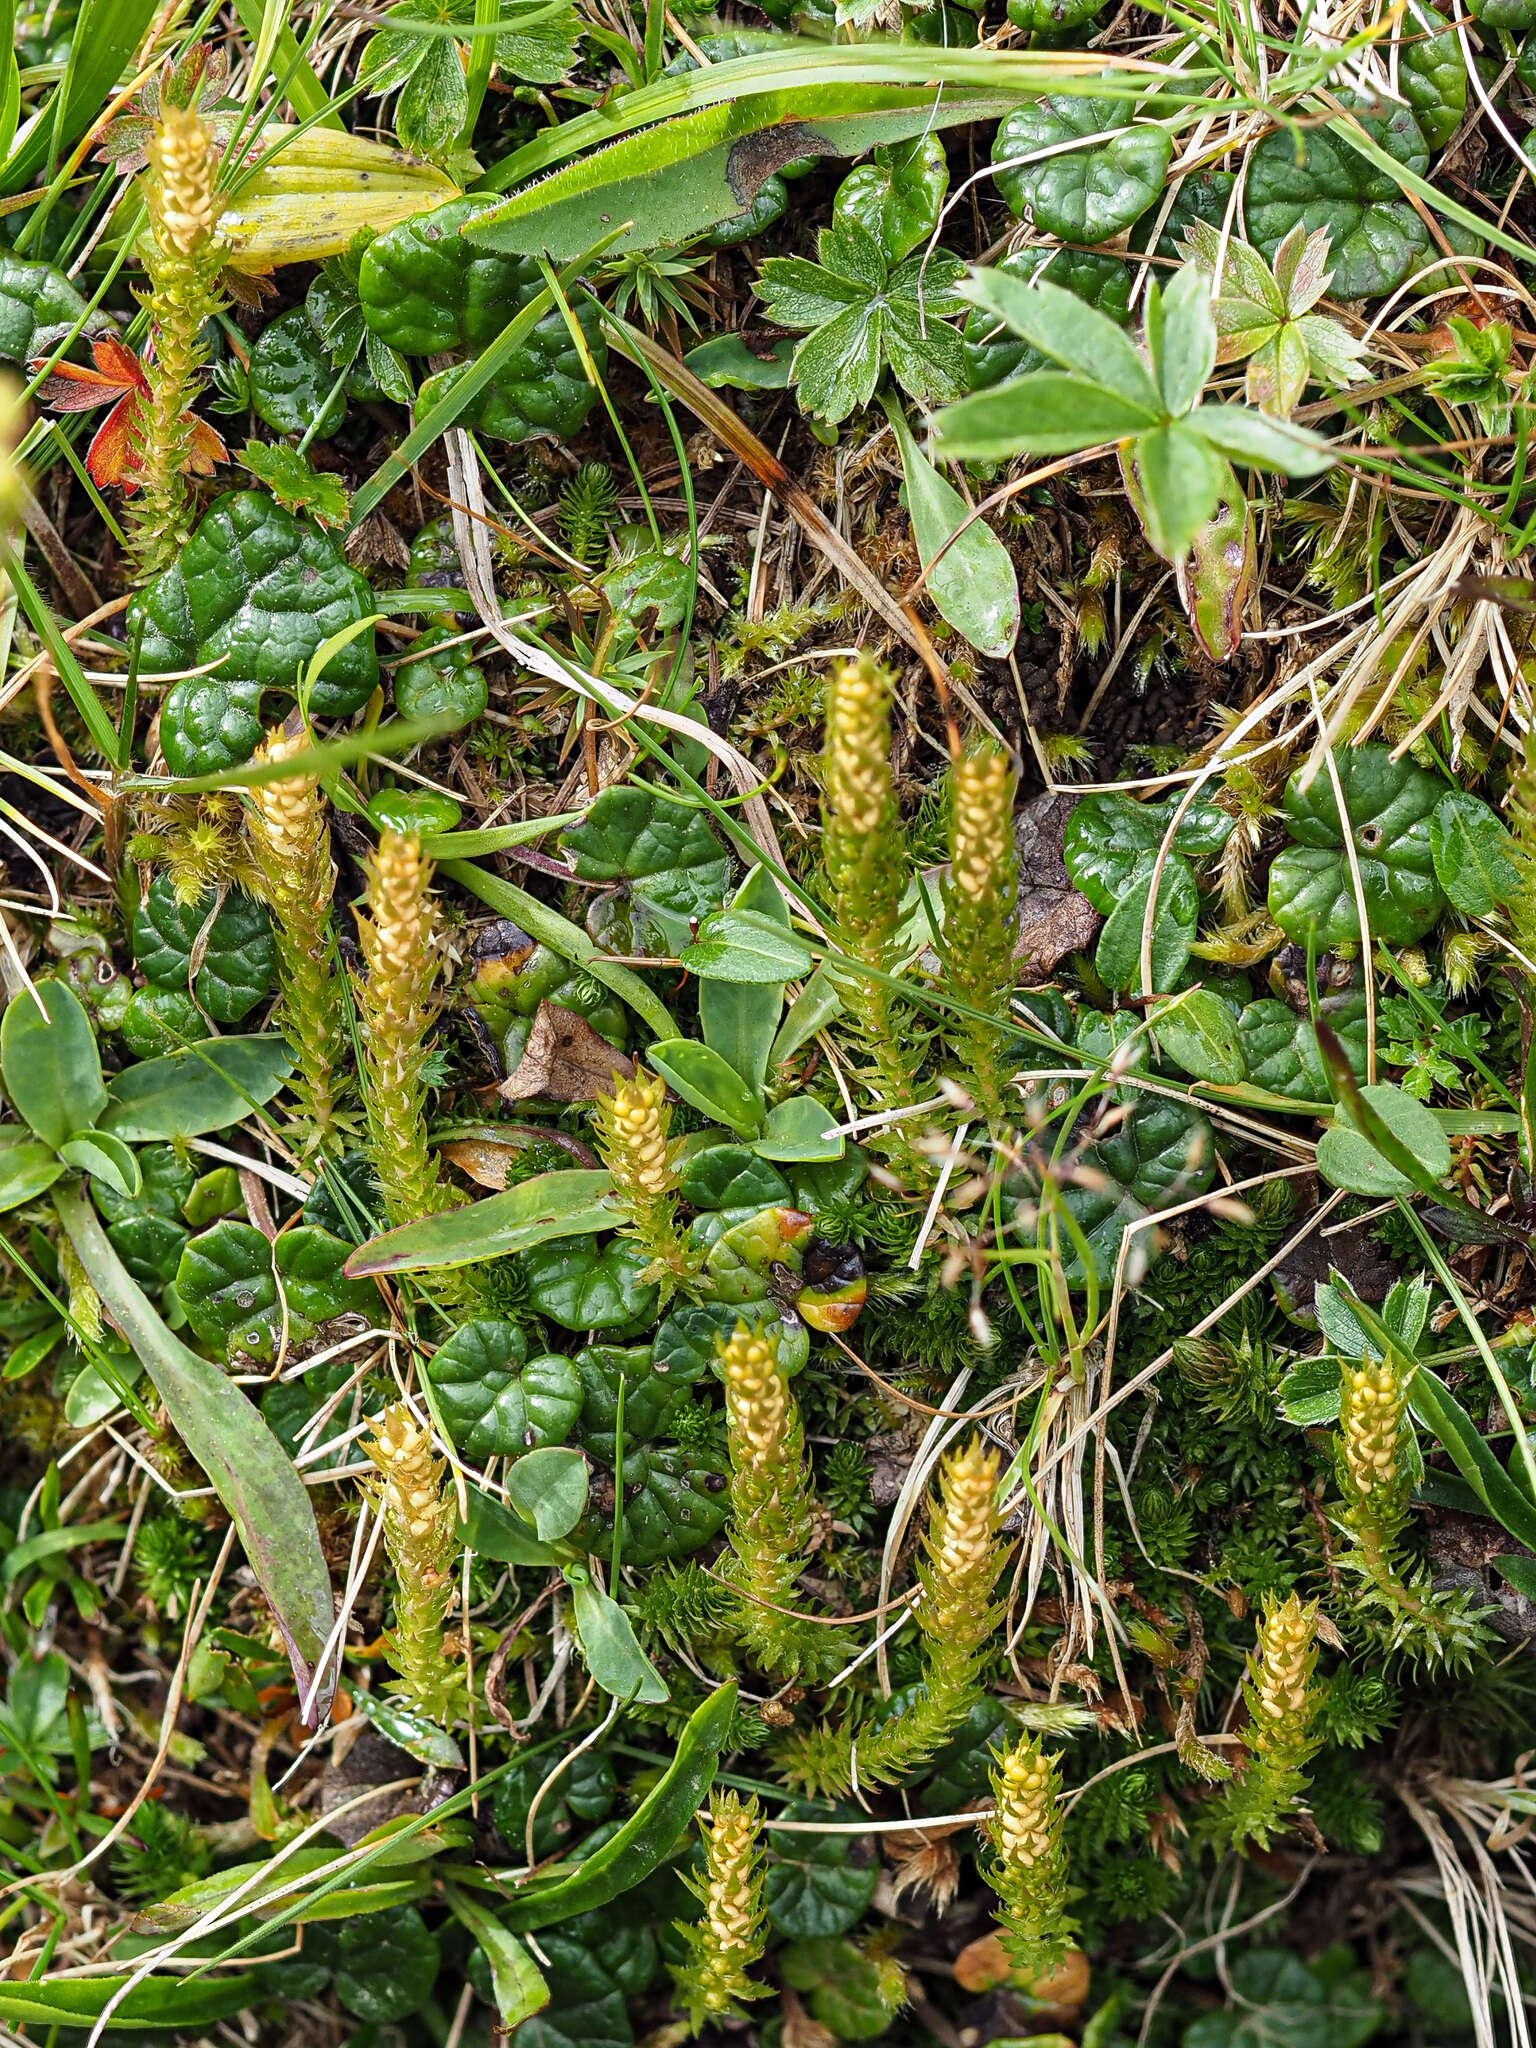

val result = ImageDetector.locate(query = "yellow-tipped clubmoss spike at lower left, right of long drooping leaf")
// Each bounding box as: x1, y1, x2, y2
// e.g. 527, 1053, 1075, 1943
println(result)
365, 1401, 461, 1722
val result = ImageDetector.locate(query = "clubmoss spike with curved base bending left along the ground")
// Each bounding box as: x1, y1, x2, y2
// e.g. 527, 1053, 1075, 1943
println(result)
782, 1438, 1012, 1792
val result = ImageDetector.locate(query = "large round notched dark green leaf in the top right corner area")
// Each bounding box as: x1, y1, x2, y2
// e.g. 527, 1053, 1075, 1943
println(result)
1247, 92, 1430, 299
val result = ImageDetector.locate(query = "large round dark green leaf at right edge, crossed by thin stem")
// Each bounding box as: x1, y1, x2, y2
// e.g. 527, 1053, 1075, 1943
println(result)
1270, 745, 1446, 948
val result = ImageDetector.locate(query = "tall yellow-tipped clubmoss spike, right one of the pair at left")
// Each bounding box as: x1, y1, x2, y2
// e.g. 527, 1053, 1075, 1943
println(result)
356, 827, 451, 1223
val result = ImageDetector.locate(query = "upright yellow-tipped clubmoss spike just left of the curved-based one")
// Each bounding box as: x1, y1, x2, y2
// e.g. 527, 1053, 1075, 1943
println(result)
719, 1323, 815, 1675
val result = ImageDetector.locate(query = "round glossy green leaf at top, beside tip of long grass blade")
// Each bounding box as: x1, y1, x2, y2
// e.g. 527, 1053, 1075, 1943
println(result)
991, 92, 1174, 242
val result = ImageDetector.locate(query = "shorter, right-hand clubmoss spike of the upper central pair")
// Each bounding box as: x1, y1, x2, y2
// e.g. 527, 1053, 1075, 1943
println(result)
942, 739, 1018, 1120
